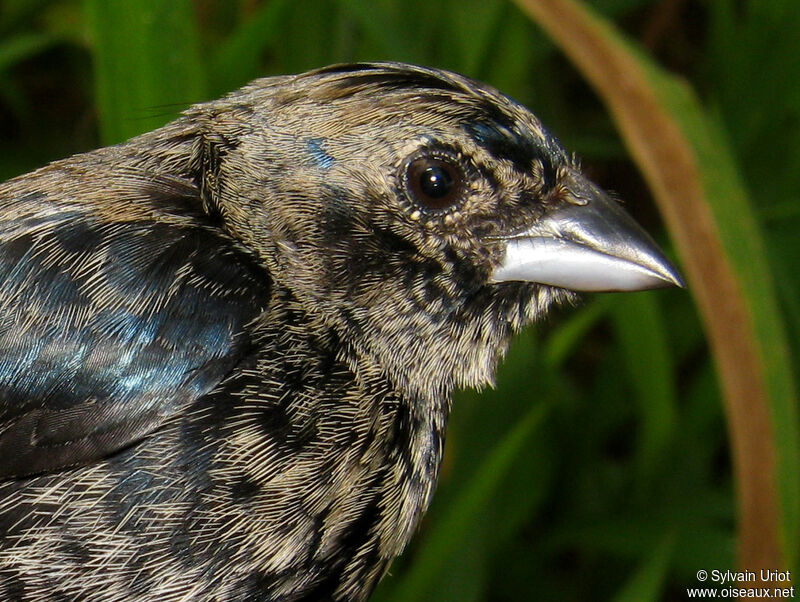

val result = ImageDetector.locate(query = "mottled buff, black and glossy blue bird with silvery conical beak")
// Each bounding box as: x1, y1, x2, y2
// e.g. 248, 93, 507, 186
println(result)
0, 63, 682, 602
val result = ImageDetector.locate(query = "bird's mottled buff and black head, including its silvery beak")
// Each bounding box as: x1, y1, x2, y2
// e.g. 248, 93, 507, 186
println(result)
189, 64, 680, 398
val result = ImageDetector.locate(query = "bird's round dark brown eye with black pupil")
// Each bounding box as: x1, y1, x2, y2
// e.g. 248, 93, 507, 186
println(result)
406, 157, 464, 211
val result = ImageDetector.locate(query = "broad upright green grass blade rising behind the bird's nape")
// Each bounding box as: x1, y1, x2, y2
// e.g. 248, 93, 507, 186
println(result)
84, 0, 205, 144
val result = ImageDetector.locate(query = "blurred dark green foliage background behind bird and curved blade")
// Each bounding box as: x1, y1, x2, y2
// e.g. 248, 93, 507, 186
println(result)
0, 0, 800, 601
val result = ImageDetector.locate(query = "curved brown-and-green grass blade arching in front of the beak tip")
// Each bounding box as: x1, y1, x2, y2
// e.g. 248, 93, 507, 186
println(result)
517, 0, 800, 568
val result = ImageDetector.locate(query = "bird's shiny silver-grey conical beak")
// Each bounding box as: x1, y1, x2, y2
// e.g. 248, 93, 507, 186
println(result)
492, 171, 683, 291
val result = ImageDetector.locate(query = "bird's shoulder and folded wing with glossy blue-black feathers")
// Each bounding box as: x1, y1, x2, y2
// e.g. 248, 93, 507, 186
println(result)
0, 157, 270, 478
